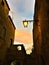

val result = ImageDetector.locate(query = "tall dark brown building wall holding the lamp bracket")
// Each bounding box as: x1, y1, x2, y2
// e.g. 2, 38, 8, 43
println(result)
33, 0, 49, 65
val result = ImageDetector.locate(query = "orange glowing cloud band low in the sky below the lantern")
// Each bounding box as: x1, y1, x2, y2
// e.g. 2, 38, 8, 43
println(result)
14, 30, 33, 44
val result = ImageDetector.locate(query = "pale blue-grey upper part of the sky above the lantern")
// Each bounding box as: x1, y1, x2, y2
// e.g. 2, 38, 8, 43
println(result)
7, 0, 35, 22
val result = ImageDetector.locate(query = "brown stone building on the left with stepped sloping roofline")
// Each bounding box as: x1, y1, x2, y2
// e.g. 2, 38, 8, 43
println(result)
0, 0, 15, 65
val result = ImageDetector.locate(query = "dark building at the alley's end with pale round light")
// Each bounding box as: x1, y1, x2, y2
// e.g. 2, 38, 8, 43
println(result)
5, 44, 35, 65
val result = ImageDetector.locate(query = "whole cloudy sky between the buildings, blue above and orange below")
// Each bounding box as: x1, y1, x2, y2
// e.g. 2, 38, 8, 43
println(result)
7, 0, 35, 54
